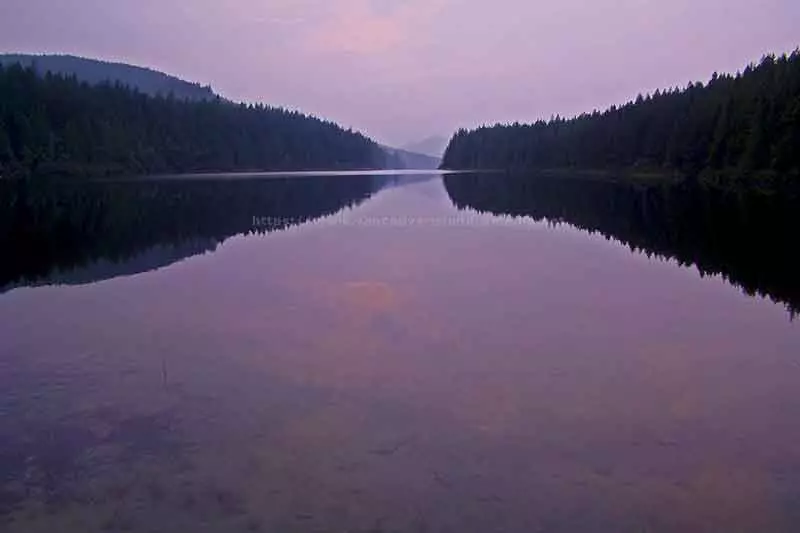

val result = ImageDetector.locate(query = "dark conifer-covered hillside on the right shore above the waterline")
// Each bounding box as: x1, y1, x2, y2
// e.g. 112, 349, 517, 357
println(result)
442, 51, 800, 181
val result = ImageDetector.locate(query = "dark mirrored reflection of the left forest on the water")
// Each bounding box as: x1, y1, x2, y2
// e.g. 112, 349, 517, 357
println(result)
0, 173, 382, 290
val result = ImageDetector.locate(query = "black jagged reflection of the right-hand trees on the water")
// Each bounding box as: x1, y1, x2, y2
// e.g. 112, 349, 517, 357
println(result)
444, 173, 800, 316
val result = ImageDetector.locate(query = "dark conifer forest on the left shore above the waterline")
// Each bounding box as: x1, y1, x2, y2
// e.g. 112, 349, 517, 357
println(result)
0, 65, 386, 176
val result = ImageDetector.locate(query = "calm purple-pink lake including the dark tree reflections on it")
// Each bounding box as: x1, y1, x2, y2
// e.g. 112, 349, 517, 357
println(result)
0, 173, 800, 533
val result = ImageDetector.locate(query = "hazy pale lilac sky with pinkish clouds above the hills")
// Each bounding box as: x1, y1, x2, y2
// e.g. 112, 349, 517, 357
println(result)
0, 0, 800, 145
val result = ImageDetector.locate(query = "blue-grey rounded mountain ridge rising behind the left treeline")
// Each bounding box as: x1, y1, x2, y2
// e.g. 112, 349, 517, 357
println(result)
0, 54, 217, 101
